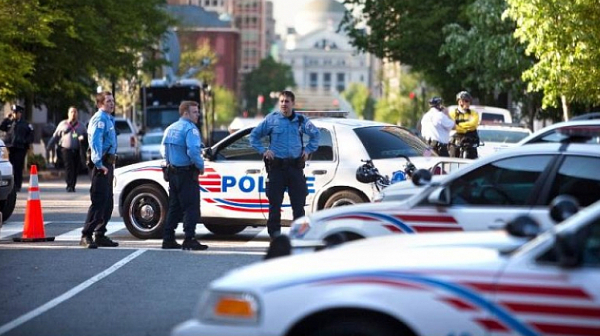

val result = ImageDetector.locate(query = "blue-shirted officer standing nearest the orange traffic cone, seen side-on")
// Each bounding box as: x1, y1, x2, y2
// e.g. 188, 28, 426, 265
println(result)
79, 91, 119, 248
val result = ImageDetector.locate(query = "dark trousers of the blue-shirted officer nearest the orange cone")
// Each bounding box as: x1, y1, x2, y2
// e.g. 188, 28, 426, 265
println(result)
81, 164, 115, 237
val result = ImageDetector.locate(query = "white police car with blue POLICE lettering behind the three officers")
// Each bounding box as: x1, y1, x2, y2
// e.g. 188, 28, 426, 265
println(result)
114, 113, 468, 239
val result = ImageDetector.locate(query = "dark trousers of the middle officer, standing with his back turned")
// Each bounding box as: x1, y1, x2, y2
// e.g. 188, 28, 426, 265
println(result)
163, 165, 200, 241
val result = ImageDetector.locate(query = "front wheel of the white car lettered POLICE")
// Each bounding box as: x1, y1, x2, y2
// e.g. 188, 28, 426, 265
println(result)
123, 185, 169, 239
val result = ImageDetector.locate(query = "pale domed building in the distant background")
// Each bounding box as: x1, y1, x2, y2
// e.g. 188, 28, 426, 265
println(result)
281, 0, 379, 109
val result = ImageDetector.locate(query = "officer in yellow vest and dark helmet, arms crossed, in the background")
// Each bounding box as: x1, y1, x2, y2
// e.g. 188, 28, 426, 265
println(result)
448, 91, 479, 159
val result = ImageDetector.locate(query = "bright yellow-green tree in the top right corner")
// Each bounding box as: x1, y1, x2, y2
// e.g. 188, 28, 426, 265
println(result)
505, 0, 600, 118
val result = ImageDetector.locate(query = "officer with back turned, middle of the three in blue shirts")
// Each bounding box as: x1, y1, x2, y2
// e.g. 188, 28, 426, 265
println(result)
161, 101, 208, 251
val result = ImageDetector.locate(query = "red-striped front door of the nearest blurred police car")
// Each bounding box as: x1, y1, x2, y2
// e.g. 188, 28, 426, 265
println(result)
488, 216, 600, 335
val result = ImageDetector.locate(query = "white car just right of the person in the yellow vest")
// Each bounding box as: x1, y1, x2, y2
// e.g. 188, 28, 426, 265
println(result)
477, 124, 531, 157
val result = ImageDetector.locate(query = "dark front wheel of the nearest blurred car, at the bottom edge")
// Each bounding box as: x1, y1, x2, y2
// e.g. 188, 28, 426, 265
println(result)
310, 316, 398, 336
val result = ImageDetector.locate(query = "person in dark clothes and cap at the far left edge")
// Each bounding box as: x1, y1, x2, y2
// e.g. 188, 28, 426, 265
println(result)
0, 105, 34, 191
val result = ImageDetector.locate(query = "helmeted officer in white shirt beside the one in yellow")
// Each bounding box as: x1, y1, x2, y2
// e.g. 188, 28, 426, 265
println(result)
421, 97, 454, 157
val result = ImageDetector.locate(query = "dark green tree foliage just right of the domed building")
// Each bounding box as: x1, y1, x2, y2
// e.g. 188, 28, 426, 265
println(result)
340, 0, 473, 96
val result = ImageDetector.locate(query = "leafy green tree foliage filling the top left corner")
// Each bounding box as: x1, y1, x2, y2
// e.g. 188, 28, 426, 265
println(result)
0, 0, 173, 118
